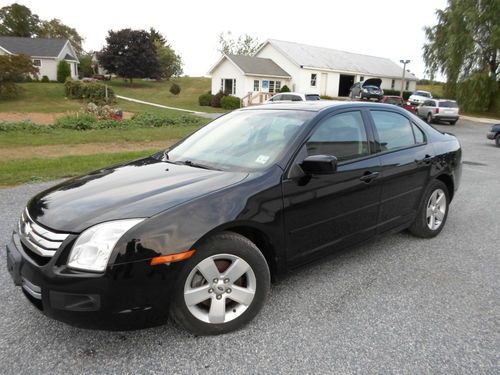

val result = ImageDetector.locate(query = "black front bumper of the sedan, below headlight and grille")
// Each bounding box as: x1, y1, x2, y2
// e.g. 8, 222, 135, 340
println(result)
6, 232, 182, 330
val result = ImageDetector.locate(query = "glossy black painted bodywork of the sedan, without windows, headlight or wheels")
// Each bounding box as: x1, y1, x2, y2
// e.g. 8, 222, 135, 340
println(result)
7, 102, 461, 328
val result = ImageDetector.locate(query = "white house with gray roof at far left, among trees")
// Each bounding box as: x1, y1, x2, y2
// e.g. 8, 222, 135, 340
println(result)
0, 36, 80, 81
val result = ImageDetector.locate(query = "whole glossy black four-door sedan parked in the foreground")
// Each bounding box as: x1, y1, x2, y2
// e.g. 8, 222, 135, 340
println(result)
7, 102, 461, 334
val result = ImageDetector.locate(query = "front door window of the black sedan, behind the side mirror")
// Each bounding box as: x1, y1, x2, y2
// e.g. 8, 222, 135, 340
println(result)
306, 111, 369, 161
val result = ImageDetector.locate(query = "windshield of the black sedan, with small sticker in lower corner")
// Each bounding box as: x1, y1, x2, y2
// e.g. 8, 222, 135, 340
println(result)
166, 110, 315, 171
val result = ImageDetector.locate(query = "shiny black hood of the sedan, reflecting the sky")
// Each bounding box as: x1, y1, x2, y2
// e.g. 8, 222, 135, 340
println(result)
28, 157, 248, 233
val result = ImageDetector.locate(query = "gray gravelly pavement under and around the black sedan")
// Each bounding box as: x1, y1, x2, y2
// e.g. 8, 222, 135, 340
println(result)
0, 121, 500, 374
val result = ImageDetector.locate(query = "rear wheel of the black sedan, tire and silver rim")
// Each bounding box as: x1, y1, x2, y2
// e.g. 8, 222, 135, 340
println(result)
409, 180, 450, 238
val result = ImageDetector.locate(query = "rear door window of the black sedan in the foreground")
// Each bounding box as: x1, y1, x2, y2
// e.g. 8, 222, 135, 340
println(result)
370, 111, 415, 152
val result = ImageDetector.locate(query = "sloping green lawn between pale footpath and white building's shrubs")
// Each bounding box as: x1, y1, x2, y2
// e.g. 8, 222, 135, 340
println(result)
109, 77, 224, 112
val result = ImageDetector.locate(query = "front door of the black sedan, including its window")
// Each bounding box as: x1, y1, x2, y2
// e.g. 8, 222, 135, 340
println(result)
283, 111, 381, 266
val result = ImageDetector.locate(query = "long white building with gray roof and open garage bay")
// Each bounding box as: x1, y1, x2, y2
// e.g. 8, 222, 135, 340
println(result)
209, 39, 417, 105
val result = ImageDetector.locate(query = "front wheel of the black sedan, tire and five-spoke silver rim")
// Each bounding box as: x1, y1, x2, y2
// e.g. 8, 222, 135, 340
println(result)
170, 232, 271, 336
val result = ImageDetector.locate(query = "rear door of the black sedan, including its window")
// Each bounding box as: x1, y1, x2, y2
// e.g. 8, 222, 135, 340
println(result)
370, 110, 434, 232
